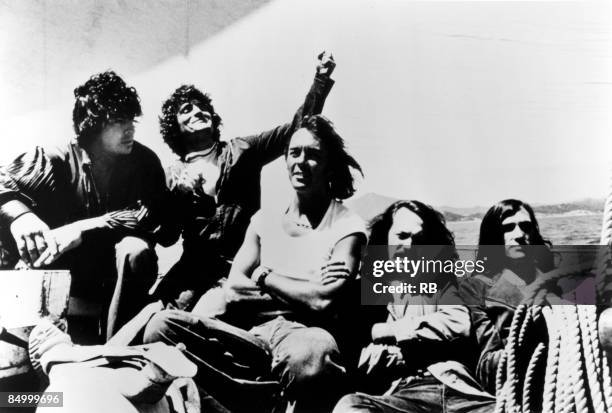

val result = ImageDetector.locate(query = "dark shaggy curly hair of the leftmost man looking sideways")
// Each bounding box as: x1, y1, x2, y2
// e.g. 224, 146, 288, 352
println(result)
72, 70, 142, 145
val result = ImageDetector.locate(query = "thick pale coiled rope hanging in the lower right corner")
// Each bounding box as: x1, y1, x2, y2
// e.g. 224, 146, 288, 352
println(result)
495, 304, 612, 413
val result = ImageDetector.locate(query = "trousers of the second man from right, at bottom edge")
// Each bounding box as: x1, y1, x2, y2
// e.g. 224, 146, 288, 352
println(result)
334, 375, 495, 413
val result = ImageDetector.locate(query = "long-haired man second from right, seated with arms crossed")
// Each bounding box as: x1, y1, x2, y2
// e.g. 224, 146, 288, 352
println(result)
334, 201, 495, 413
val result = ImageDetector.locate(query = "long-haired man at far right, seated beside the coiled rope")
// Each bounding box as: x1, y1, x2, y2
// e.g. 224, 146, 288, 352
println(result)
460, 199, 553, 394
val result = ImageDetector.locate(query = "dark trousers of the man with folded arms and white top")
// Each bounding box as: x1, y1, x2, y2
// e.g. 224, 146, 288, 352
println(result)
144, 310, 346, 412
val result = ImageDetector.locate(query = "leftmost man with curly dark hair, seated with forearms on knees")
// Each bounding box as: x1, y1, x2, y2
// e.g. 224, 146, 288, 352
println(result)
0, 71, 172, 337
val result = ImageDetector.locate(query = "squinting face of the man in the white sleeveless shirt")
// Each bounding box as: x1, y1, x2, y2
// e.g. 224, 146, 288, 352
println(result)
286, 129, 328, 192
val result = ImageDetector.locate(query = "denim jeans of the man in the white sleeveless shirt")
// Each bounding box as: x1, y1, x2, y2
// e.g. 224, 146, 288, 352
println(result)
144, 310, 346, 412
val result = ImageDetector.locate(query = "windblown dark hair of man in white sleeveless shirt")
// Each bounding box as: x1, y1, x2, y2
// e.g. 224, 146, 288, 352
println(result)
285, 115, 363, 200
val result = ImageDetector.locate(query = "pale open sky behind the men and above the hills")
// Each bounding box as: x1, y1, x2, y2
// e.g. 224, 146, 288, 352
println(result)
0, 0, 612, 207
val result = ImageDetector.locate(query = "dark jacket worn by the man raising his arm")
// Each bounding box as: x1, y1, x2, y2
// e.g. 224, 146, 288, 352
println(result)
168, 76, 334, 262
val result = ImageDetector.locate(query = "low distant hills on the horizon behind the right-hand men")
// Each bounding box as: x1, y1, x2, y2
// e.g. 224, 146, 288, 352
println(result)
347, 192, 604, 222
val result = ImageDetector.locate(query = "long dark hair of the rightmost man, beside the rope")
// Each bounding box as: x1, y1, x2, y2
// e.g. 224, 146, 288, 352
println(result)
476, 199, 554, 273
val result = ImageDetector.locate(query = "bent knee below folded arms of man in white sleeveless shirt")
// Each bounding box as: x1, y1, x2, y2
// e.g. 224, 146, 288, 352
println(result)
273, 328, 345, 384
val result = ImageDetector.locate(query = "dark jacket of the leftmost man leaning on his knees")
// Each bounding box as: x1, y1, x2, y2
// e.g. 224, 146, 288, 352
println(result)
0, 141, 172, 264
